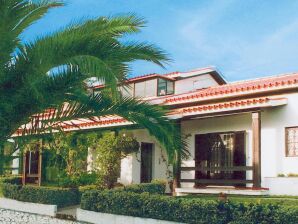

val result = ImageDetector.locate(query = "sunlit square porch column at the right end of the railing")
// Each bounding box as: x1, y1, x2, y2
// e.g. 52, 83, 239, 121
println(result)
252, 111, 261, 188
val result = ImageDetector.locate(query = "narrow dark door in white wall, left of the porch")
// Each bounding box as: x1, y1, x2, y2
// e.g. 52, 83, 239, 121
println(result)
141, 142, 153, 183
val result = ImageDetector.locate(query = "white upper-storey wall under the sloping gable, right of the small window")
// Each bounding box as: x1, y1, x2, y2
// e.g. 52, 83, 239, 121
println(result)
175, 74, 218, 94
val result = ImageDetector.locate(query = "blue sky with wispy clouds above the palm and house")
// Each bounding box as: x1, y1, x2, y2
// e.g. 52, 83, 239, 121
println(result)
23, 0, 298, 81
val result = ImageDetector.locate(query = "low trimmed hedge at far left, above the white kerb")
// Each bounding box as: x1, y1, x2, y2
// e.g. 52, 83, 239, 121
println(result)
2, 183, 80, 207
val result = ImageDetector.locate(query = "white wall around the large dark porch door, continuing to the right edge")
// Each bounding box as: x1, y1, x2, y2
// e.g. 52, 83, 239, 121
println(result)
182, 93, 298, 188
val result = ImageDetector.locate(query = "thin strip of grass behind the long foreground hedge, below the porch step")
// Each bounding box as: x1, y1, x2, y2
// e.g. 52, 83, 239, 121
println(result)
180, 194, 298, 206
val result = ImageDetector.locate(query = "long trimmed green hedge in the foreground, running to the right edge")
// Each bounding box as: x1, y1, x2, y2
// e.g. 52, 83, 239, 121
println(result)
81, 190, 298, 224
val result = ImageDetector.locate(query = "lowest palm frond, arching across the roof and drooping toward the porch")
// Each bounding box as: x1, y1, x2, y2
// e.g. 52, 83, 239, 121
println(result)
20, 94, 187, 162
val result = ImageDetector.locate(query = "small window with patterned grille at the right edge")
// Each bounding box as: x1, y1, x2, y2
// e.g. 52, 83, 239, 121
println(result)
286, 127, 298, 156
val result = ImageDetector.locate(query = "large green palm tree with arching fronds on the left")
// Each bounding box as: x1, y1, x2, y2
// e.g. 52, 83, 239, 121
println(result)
0, 0, 183, 184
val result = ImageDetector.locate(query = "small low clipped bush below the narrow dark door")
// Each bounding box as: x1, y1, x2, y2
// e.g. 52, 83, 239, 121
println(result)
124, 180, 166, 194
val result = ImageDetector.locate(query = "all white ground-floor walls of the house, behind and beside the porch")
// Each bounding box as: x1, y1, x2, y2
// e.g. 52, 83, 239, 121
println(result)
121, 93, 298, 194
